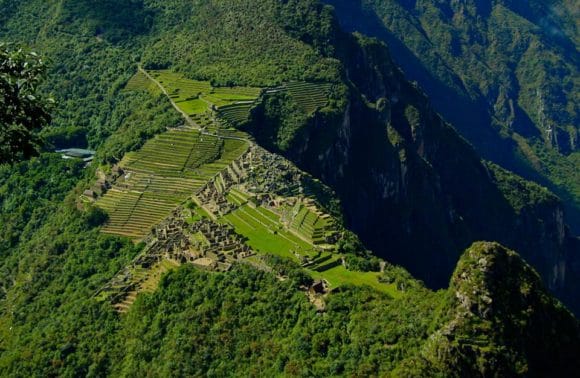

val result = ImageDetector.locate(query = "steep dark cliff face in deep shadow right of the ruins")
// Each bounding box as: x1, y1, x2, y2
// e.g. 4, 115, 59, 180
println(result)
260, 31, 575, 314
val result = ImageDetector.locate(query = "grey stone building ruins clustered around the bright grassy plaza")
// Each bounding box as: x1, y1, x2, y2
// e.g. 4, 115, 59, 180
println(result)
95, 137, 338, 311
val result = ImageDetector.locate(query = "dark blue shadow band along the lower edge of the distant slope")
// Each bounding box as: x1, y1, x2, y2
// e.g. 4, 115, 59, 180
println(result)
325, 0, 580, 233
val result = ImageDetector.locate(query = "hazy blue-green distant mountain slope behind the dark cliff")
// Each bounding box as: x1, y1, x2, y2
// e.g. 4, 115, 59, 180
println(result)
327, 0, 580, 232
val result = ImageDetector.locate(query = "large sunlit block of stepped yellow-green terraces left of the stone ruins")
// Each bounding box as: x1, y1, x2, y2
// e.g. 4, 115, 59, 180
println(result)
97, 130, 248, 239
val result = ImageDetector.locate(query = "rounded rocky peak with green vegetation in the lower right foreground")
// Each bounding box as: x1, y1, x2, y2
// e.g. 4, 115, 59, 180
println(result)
398, 242, 580, 377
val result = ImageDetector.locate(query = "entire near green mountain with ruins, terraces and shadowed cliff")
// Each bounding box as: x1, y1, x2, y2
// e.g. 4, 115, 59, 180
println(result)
0, 0, 580, 376
